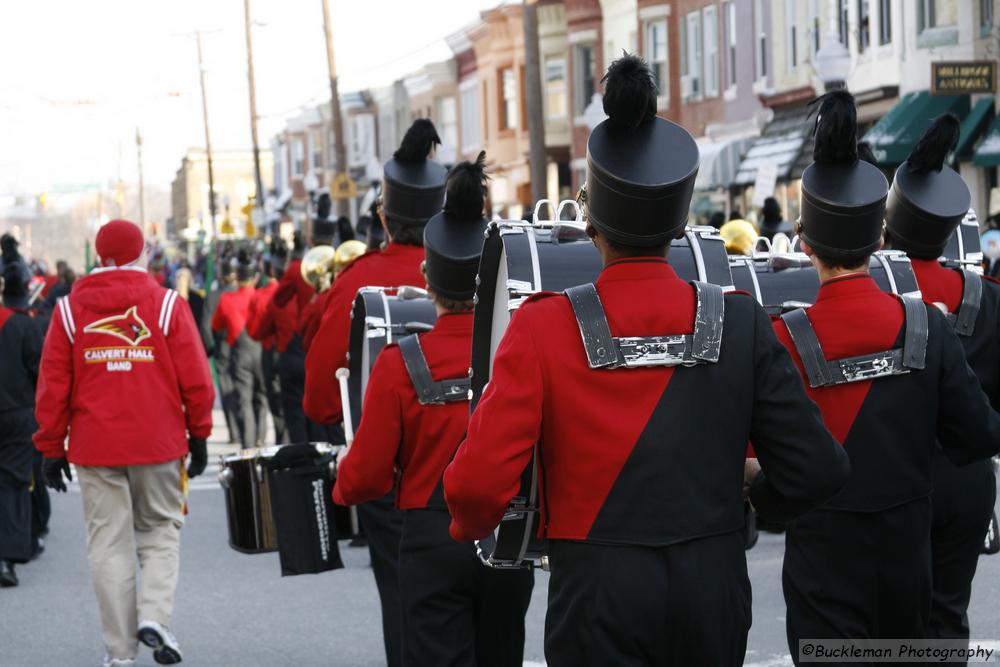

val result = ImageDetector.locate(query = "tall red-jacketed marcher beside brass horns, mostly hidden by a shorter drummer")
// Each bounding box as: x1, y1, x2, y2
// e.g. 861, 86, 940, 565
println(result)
303, 119, 448, 667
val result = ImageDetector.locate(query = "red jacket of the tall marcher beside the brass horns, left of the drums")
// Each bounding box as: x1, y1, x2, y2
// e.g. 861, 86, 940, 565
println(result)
302, 243, 426, 424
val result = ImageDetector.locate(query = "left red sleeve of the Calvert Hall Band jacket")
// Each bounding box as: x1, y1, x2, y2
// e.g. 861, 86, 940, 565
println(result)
33, 308, 73, 458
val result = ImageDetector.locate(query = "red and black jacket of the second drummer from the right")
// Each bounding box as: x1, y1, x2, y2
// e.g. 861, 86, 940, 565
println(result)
772, 273, 1000, 512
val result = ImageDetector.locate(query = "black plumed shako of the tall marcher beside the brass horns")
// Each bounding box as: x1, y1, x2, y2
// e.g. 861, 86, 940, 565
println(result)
382, 118, 448, 226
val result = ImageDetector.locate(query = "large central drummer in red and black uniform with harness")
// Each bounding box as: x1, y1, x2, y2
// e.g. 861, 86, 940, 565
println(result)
444, 55, 849, 667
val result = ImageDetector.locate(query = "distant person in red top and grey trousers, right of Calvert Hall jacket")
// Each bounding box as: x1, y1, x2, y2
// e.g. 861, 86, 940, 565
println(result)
212, 250, 267, 449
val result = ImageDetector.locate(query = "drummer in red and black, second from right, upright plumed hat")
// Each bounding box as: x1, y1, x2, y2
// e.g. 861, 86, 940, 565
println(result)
768, 91, 1000, 664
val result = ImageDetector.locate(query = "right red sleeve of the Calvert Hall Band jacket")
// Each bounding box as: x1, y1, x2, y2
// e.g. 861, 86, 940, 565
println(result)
164, 298, 215, 438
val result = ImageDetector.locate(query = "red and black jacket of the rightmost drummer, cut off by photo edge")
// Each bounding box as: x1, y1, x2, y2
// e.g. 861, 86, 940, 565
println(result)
911, 259, 1000, 409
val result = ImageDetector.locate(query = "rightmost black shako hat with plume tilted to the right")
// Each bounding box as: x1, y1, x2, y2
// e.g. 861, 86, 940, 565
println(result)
885, 113, 972, 259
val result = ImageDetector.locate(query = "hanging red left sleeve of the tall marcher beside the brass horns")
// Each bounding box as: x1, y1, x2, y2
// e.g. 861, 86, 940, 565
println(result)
302, 283, 354, 424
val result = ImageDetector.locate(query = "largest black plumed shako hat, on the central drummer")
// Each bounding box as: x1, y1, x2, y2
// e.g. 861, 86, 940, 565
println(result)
586, 53, 698, 247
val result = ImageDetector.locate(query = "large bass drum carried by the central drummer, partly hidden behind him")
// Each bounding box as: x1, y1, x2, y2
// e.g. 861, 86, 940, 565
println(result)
472, 221, 733, 568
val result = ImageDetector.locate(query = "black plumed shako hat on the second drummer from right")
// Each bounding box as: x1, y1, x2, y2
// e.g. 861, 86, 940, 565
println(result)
799, 90, 889, 260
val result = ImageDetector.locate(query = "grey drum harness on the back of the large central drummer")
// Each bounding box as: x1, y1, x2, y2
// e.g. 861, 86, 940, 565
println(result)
565, 281, 725, 369
